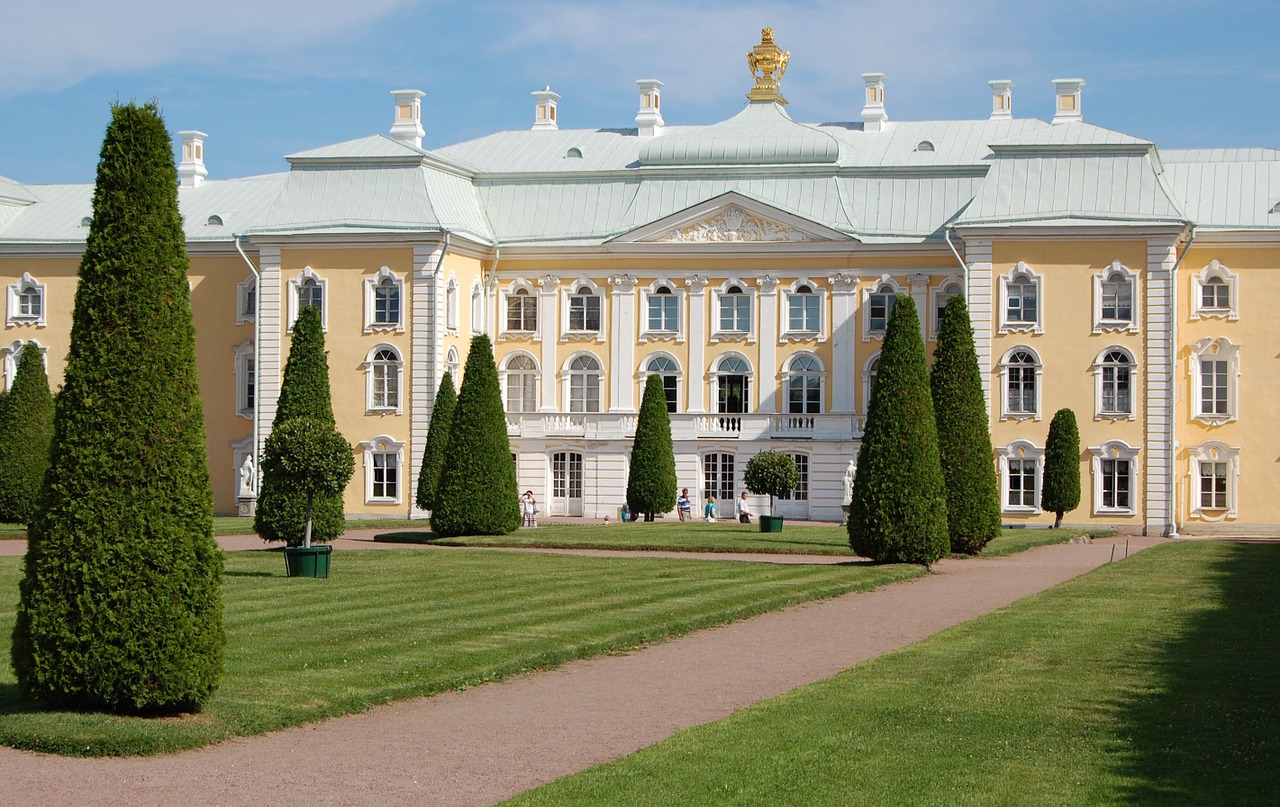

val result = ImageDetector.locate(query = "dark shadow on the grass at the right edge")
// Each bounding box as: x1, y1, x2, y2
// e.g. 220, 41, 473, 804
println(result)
1115, 543, 1280, 807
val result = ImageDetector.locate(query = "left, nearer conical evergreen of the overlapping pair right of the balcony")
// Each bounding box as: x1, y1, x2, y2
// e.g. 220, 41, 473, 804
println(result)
849, 296, 951, 566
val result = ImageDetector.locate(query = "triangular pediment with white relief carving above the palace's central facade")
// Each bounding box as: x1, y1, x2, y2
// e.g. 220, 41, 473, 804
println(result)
614, 191, 849, 243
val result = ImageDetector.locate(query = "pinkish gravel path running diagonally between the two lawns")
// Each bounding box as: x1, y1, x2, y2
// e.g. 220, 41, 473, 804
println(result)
0, 534, 1161, 807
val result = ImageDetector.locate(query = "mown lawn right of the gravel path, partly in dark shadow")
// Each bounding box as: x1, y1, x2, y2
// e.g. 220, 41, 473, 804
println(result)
508, 542, 1280, 807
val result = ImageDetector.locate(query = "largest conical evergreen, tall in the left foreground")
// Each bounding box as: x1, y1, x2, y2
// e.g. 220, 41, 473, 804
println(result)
13, 104, 225, 712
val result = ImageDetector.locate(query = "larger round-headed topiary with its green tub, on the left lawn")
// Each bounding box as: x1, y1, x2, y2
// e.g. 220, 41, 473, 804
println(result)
262, 418, 356, 578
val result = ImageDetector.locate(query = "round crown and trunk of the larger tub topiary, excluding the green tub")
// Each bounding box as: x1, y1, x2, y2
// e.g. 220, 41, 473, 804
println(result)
262, 418, 356, 547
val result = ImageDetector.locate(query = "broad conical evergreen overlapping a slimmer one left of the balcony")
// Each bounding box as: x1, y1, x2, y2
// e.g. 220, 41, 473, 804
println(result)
431, 334, 520, 535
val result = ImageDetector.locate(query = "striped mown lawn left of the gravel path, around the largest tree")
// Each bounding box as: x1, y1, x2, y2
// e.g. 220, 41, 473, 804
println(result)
0, 550, 923, 756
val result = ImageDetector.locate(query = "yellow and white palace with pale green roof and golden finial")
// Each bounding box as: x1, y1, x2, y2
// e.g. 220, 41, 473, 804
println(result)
0, 29, 1280, 534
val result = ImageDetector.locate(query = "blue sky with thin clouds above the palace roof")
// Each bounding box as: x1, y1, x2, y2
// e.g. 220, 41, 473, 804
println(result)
0, 0, 1280, 183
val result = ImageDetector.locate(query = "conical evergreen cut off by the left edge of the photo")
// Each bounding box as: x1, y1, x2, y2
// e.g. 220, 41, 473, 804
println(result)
0, 346, 54, 524
